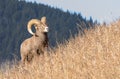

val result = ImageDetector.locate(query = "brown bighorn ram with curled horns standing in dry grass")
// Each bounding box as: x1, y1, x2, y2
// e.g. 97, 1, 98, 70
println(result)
20, 17, 48, 63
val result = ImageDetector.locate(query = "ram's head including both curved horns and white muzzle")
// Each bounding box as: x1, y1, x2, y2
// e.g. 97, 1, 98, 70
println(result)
27, 17, 48, 35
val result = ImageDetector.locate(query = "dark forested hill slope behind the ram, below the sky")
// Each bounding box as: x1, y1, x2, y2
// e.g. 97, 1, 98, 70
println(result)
0, 0, 93, 62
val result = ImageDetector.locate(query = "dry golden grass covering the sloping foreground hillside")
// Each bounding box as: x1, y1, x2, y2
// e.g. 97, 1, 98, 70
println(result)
0, 21, 120, 79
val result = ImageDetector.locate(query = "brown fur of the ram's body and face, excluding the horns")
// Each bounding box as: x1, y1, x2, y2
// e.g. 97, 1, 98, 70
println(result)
20, 16, 48, 63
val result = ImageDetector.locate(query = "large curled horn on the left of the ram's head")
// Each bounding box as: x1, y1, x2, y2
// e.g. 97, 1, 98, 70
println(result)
27, 19, 40, 35
